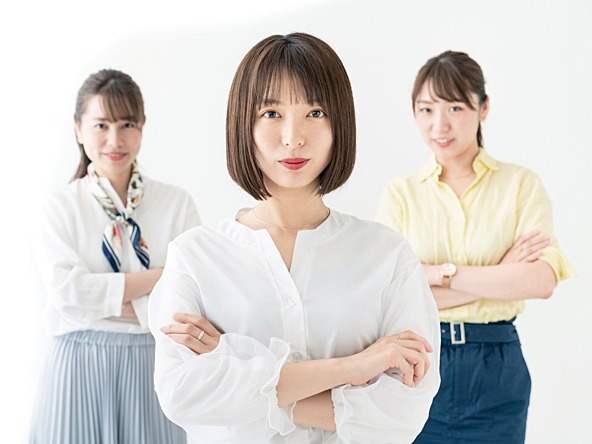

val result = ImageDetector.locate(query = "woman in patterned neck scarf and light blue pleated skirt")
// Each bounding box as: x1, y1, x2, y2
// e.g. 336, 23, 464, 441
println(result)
30, 69, 199, 444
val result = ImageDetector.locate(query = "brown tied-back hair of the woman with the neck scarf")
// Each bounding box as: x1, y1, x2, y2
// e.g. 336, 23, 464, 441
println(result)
72, 69, 146, 180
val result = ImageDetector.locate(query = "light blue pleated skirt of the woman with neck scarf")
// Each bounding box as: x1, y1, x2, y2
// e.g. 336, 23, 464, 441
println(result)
30, 331, 187, 444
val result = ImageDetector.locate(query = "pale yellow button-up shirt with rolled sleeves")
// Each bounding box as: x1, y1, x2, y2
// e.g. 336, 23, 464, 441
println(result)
376, 149, 576, 323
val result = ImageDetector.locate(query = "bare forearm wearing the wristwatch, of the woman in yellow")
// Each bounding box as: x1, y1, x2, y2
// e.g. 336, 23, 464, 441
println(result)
424, 261, 556, 301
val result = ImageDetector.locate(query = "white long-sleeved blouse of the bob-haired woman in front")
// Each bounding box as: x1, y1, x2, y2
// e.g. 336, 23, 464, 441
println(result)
149, 211, 440, 444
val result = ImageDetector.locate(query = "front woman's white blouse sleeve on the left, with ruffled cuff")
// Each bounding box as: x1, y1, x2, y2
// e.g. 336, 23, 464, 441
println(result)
149, 242, 294, 436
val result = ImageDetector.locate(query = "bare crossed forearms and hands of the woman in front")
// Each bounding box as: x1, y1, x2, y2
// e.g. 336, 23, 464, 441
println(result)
161, 313, 432, 431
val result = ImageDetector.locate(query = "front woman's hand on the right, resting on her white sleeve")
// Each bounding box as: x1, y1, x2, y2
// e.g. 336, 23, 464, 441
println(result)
343, 330, 433, 387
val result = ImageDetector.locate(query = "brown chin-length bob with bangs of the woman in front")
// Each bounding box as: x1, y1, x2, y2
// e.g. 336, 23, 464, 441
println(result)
226, 33, 356, 200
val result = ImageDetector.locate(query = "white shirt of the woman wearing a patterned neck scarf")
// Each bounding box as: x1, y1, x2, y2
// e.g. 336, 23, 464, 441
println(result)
33, 176, 199, 335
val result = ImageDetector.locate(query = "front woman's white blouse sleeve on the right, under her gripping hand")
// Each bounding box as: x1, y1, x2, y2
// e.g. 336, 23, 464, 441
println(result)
332, 242, 440, 444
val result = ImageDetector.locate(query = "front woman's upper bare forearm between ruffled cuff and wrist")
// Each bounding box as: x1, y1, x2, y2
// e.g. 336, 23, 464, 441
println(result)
277, 359, 346, 407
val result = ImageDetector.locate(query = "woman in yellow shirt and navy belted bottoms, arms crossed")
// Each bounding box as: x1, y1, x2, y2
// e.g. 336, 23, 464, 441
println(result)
377, 51, 575, 444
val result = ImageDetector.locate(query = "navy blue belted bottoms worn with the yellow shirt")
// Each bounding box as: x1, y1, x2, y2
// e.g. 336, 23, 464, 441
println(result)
414, 321, 530, 444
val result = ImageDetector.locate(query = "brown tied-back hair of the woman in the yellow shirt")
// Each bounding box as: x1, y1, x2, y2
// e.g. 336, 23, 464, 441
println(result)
411, 51, 487, 147
